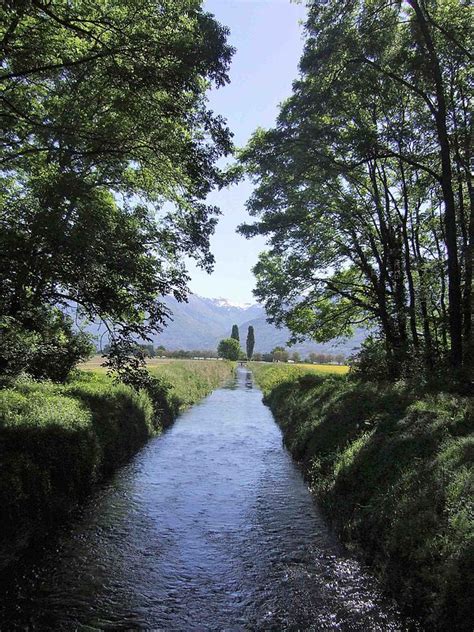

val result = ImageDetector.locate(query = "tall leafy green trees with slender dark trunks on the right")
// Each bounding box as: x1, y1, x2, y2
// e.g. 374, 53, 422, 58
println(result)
241, 0, 474, 383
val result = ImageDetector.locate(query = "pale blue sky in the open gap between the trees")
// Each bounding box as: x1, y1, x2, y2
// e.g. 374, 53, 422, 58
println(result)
189, 0, 305, 302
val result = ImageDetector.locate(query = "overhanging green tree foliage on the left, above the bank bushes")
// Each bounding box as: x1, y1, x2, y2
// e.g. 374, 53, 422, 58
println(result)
0, 0, 232, 373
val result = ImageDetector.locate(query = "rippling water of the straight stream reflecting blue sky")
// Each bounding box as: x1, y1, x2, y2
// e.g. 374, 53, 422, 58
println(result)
0, 369, 412, 632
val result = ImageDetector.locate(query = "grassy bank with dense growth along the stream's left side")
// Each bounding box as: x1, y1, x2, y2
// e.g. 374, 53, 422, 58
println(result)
0, 361, 232, 567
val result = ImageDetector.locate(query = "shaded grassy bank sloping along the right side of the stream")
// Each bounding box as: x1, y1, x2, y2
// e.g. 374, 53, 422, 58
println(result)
250, 365, 474, 631
